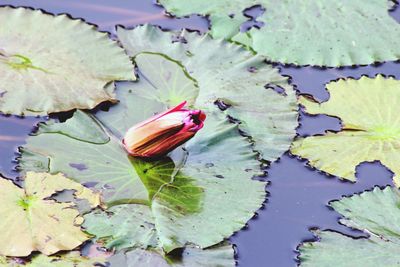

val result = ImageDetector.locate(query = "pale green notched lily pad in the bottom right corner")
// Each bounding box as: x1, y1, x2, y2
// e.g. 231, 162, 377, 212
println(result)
299, 187, 400, 267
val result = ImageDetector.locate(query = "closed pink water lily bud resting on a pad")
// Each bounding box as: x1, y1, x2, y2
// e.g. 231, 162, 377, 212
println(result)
122, 101, 206, 158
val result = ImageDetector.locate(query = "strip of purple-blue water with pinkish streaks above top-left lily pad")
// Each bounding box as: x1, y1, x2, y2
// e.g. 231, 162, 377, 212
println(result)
0, 0, 208, 31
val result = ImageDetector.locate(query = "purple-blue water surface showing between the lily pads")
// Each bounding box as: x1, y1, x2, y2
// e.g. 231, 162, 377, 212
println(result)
0, 0, 400, 267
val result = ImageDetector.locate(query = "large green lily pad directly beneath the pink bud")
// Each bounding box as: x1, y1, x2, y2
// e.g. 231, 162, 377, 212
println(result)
19, 59, 265, 252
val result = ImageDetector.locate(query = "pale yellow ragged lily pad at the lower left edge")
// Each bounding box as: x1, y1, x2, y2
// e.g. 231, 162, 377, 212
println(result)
0, 172, 99, 256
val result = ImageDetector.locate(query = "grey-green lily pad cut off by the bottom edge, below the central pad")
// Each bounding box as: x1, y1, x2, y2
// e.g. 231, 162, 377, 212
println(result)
110, 244, 235, 267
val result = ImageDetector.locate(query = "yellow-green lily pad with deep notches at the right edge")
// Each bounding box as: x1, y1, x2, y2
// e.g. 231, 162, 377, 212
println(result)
291, 75, 400, 186
